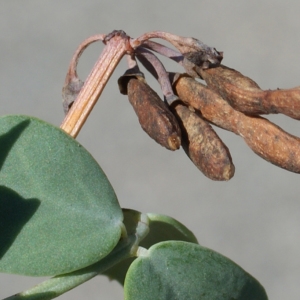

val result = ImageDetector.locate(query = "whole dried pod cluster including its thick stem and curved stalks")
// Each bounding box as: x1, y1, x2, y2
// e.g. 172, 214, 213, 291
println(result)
61, 30, 300, 180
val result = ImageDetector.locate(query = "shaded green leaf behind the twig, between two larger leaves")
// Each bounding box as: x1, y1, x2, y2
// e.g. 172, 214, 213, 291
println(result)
103, 209, 197, 285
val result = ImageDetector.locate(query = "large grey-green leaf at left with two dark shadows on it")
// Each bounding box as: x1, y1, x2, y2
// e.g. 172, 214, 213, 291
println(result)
0, 116, 123, 276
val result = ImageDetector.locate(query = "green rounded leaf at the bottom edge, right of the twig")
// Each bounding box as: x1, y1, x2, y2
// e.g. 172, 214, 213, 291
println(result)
124, 241, 267, 300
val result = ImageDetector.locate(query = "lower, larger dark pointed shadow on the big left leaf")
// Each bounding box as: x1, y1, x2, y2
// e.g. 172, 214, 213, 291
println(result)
0, 186, 40, 258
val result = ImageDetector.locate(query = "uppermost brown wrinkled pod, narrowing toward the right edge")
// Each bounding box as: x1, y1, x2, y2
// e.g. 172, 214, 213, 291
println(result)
197, 65, 300, 120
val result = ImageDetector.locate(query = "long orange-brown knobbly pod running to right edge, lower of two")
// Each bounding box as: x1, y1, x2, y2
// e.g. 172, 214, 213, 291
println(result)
174, 77, 300, 173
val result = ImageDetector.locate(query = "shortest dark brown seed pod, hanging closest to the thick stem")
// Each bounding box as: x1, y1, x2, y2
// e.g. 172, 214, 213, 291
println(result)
127, 77, 181, 150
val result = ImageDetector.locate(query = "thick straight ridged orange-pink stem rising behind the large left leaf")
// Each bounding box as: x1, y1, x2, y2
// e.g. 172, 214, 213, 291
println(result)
60, 35, 127, 138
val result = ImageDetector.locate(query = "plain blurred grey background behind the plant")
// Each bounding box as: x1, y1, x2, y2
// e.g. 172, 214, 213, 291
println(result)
0, 0, 300, 300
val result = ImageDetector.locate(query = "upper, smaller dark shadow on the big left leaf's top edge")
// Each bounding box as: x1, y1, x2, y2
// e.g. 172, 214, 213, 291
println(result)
0, 120, 30, 170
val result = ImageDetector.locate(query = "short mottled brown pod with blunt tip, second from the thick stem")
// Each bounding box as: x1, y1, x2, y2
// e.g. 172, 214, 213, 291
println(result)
172, 102, 235, 181
